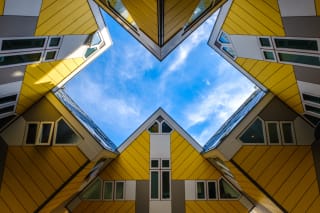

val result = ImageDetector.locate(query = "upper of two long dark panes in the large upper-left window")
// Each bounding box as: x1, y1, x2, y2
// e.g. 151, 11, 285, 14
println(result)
1, 38, 45, 50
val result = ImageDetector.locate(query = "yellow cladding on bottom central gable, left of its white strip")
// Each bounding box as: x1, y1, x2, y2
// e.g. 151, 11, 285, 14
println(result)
100, 131, 150, 180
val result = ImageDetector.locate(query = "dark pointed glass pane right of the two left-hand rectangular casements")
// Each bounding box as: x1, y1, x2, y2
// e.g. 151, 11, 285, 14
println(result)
55, 119, 80, 144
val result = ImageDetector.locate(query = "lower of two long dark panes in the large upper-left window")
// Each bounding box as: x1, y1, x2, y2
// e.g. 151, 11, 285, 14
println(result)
0, 53, 41, 66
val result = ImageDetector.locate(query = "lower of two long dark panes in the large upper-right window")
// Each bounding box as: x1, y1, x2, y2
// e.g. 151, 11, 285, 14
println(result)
278, 53, 320, 66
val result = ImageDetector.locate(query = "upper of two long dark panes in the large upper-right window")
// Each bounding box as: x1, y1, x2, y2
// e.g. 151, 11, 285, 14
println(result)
274, 38, 318, 50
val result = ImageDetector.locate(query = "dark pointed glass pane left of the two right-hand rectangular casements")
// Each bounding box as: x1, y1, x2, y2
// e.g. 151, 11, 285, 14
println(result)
240, 119, 264, 143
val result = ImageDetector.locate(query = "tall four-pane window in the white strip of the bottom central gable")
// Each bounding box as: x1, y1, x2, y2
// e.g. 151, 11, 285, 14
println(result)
150, 159, 171, 200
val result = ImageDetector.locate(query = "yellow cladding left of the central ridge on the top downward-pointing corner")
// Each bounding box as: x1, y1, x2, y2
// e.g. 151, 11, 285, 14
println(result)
122, 0, 159, 44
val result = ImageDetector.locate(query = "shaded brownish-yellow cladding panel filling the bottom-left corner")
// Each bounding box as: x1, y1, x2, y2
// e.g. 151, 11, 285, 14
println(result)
0, 146, 86, 212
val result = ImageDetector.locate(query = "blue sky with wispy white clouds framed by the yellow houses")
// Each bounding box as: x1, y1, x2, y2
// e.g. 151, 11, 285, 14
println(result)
65, 11, 255, 145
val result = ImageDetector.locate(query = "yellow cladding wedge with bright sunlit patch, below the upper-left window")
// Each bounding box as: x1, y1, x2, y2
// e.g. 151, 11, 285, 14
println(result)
16, 58, 84, 114
